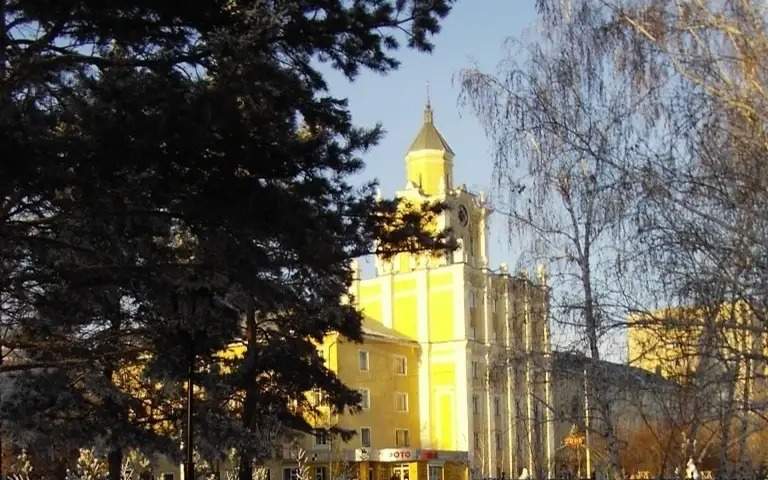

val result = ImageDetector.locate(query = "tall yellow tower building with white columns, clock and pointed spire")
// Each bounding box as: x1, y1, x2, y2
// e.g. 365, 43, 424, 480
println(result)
352, 105, 553, 477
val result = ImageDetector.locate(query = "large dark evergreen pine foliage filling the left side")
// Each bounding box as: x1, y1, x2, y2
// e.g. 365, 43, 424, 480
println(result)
0, 0, 451, 475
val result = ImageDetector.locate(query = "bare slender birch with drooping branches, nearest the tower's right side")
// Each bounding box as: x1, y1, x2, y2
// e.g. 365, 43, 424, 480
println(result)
460, 7, 652, 475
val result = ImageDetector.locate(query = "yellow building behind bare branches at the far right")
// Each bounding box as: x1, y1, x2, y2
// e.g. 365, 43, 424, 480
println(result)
628, 301, 768, 467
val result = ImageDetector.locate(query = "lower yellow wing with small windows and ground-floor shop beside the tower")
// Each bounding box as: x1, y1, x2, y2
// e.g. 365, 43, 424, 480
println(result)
266, 318, 468, 480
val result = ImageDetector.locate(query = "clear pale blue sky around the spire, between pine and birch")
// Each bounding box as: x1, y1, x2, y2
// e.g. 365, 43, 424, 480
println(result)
327, 0, 536, 274
